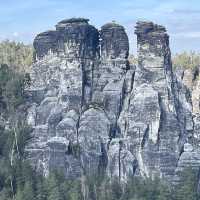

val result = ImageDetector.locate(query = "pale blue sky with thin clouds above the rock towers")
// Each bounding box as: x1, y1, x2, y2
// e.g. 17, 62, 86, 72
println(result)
0, 0, 200, 53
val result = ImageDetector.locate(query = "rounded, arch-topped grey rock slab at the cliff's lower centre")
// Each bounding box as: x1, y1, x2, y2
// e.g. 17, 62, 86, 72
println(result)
78, 107, 111, 174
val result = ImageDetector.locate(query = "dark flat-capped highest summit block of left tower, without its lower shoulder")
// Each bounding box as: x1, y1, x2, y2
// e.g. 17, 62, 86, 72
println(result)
56, 19, 99, 59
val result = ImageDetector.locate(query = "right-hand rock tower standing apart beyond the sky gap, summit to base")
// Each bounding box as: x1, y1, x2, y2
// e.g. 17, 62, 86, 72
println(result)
119, 22, 181, 180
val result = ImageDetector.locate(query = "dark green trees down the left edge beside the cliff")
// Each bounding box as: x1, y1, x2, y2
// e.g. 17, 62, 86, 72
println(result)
0, 64, 30, 199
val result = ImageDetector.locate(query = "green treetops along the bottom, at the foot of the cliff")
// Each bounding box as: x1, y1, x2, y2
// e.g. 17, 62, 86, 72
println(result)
0, 167, 200, 200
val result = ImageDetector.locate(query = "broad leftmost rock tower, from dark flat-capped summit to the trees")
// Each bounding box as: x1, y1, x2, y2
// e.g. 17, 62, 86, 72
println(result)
27, 18, 99, 176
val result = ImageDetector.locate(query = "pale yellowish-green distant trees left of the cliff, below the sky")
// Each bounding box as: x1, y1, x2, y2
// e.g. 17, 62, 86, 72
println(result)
0, 40, 33, 72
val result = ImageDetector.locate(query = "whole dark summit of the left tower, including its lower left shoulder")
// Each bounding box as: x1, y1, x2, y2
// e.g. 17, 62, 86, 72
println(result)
34, 18, 99, 59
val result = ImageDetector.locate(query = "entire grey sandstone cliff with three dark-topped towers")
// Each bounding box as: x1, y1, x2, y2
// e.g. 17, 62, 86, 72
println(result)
27, 18, 200, 181
